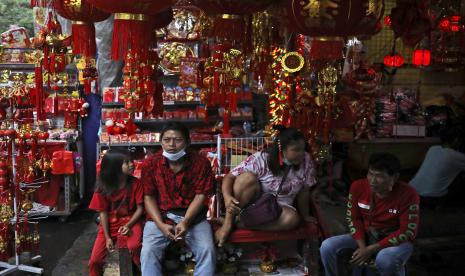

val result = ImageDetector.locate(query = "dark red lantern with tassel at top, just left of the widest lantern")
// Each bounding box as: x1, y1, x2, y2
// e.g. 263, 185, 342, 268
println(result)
191, 0, 274, 41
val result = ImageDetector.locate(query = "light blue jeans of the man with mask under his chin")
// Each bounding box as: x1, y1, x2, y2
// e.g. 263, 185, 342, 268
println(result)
141, 220, 216, 276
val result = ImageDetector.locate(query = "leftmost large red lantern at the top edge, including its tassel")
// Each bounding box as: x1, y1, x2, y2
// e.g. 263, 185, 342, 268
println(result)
53, 0, 110, 56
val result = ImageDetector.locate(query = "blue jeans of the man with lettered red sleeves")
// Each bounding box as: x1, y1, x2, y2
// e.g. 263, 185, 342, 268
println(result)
320, 234, 413, 276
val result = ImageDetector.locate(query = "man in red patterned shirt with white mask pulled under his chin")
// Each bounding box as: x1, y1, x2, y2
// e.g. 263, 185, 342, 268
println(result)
141, 123, 216, 276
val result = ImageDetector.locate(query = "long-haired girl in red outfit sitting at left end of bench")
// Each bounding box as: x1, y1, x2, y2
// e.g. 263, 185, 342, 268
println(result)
89, 150, 144, 276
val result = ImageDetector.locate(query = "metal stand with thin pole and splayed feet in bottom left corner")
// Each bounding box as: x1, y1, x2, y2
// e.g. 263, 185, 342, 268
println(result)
0, 141, 44, 275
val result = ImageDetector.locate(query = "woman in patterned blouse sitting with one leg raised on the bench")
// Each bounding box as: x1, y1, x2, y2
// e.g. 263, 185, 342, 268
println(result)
215, 126, 316, 246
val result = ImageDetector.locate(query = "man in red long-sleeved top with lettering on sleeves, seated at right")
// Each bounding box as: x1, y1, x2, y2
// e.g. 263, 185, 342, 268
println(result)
320, 153, 420, 276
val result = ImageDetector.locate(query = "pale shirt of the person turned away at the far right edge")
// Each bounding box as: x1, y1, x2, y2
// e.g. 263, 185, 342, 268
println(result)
410, 145, 465, 197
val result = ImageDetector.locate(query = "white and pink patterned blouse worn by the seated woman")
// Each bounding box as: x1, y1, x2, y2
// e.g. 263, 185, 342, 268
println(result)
230, 152, 316, 206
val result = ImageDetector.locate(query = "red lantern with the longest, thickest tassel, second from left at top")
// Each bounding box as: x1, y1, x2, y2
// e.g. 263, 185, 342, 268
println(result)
89, 0, 175, 60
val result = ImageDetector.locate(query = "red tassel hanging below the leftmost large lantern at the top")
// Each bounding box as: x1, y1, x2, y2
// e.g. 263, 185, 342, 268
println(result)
71, 21, 97, 57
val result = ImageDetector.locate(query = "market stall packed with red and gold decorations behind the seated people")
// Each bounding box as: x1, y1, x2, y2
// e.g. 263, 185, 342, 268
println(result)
0, 0, 465, 273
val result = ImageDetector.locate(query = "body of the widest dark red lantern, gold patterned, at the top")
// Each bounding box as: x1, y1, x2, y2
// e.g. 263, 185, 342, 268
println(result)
277, 0, 384, 36
